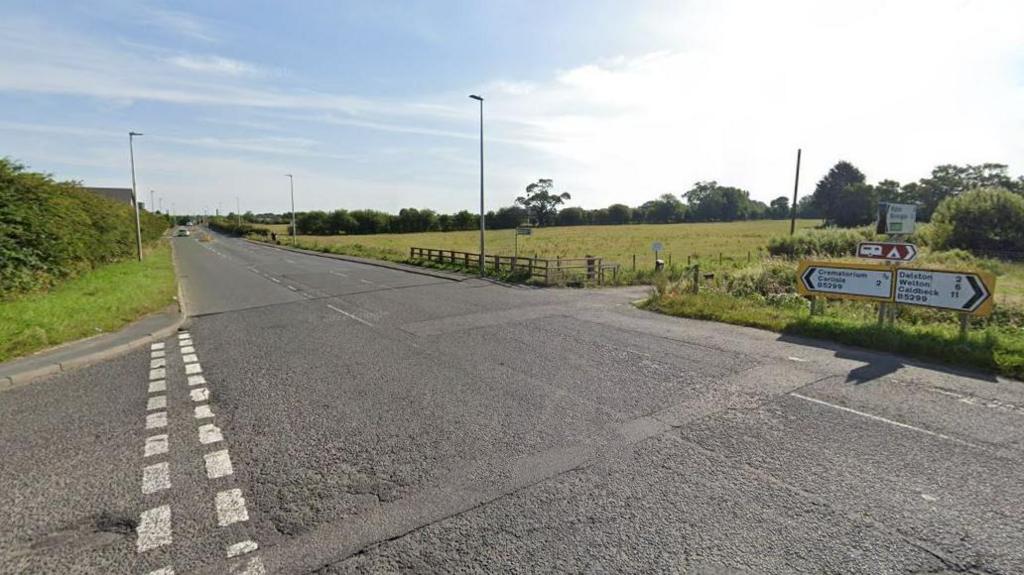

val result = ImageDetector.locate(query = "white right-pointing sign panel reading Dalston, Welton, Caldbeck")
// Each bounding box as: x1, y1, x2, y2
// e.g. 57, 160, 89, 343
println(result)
896, 269, 991, 312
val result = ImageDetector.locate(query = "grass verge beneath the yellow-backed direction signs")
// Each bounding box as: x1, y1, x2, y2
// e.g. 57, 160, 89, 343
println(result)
641, 292, 1024, 380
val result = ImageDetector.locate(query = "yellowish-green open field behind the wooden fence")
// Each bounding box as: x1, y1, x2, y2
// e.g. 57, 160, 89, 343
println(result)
264, 220, 820, 269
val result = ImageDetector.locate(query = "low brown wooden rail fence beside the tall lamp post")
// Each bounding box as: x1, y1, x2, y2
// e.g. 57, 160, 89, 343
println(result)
409, 248, 618, 284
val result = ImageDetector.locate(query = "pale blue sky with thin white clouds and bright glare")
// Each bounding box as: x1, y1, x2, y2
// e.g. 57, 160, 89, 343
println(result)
0, 0, 1024, 214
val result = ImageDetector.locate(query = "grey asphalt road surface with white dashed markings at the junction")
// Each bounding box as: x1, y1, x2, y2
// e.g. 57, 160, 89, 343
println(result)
0, 230, 1024, 575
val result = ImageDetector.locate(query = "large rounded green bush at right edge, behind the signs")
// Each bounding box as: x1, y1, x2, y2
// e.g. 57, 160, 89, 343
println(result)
931, 187, 1024, 252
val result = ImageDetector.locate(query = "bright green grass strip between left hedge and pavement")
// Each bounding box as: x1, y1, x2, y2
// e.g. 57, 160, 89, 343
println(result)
0, 240, 177, 361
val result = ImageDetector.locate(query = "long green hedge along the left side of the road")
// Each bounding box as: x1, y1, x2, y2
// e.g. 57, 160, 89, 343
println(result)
0, 159, 169, 299
